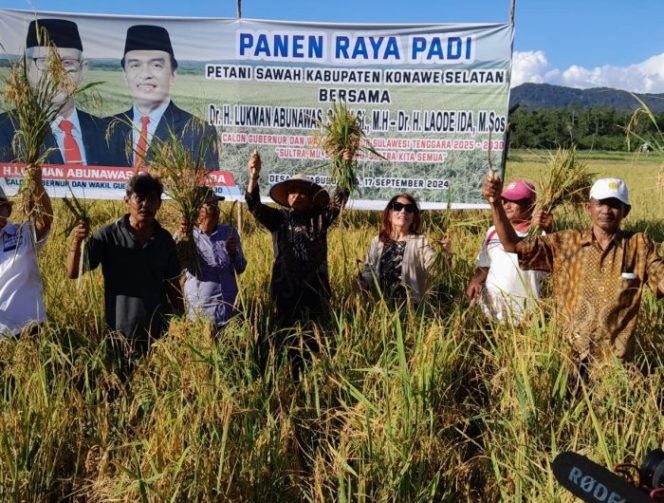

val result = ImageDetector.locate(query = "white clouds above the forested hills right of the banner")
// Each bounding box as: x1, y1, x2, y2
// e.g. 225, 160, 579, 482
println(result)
512, 51, 664, 93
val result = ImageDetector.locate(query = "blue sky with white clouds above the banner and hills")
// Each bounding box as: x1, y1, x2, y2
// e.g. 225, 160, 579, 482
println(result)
2, 0, 664, 93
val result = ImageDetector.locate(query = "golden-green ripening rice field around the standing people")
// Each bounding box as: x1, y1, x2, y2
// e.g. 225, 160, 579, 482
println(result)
0, 153, 664, 502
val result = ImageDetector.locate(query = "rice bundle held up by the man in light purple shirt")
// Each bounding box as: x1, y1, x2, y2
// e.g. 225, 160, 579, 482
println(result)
149, 126, 213, 274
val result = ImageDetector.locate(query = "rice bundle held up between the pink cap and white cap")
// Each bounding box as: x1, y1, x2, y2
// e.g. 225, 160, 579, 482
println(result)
528, 147, 595, 235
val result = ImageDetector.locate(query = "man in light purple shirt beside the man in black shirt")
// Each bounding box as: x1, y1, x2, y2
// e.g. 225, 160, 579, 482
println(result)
176, 187, 247, 328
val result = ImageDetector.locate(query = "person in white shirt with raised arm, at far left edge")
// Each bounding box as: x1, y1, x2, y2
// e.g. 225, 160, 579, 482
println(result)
0, 172, 53, 337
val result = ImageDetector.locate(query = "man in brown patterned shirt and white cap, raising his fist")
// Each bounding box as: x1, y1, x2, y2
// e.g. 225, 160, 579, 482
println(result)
483, 178, 664, 367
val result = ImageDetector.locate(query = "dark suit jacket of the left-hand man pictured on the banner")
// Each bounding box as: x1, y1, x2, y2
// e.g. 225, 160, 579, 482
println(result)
0, 109, 112, 166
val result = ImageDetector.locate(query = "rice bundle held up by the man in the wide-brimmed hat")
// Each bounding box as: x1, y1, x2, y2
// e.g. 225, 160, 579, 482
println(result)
317, 102, 385, 192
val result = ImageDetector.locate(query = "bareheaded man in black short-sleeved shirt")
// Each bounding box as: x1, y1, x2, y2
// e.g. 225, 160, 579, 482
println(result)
67, 173, 184, 356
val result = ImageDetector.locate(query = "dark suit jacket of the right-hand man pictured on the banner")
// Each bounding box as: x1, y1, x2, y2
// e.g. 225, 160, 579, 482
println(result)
108, 101, 219, 170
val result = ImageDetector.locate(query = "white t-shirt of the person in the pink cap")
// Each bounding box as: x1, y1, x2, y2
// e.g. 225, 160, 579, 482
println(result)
477, 226, 546, 323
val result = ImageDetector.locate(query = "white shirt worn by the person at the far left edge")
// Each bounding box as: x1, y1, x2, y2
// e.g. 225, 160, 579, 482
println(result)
0, 222, 46, 337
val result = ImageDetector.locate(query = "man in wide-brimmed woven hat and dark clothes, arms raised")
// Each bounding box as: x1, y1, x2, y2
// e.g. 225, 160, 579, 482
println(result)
246, 152, 348, 327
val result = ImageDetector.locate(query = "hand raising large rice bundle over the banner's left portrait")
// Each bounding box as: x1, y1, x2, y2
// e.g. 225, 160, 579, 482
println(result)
4, 30, 97, 220
